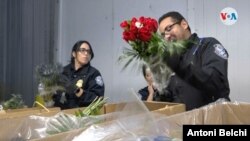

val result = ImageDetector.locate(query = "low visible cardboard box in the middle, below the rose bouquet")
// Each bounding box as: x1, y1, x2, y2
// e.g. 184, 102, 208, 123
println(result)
104, 101, 185, 115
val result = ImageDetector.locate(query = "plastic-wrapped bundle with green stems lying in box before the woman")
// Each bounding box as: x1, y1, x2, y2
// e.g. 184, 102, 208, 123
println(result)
46, 97, 108, 134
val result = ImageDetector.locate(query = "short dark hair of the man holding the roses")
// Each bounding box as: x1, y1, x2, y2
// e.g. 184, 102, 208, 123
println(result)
158, 11, 191, 32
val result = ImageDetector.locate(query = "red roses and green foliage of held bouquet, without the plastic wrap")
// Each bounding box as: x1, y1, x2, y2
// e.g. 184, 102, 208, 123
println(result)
119, 16, 188, 67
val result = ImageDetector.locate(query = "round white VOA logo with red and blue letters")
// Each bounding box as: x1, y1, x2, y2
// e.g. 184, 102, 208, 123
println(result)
220, 7, 238, 25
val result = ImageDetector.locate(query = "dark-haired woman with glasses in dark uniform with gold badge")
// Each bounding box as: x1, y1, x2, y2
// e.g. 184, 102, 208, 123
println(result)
53, 41, 105, 109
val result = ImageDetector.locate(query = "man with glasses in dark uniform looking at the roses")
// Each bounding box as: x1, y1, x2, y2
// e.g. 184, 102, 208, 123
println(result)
158, 11, 230, 110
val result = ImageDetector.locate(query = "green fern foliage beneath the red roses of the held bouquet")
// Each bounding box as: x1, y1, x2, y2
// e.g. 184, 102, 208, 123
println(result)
118, 33, 191, 69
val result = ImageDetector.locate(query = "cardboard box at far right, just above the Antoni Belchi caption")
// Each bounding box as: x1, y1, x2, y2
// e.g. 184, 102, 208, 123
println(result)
168, 102, 250, 125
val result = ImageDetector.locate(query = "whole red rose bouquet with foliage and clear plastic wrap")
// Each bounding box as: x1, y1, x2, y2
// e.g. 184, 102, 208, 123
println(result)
118, 16, 187, 92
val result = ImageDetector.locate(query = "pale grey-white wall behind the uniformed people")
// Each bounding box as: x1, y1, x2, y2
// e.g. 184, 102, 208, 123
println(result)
58, 0, 250, 102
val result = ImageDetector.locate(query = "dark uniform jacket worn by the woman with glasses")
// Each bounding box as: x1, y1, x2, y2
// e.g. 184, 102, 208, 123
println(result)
54, 64, 105, 109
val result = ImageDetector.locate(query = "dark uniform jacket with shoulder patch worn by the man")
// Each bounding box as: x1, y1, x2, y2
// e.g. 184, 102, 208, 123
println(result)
167, 34, 230, 110
